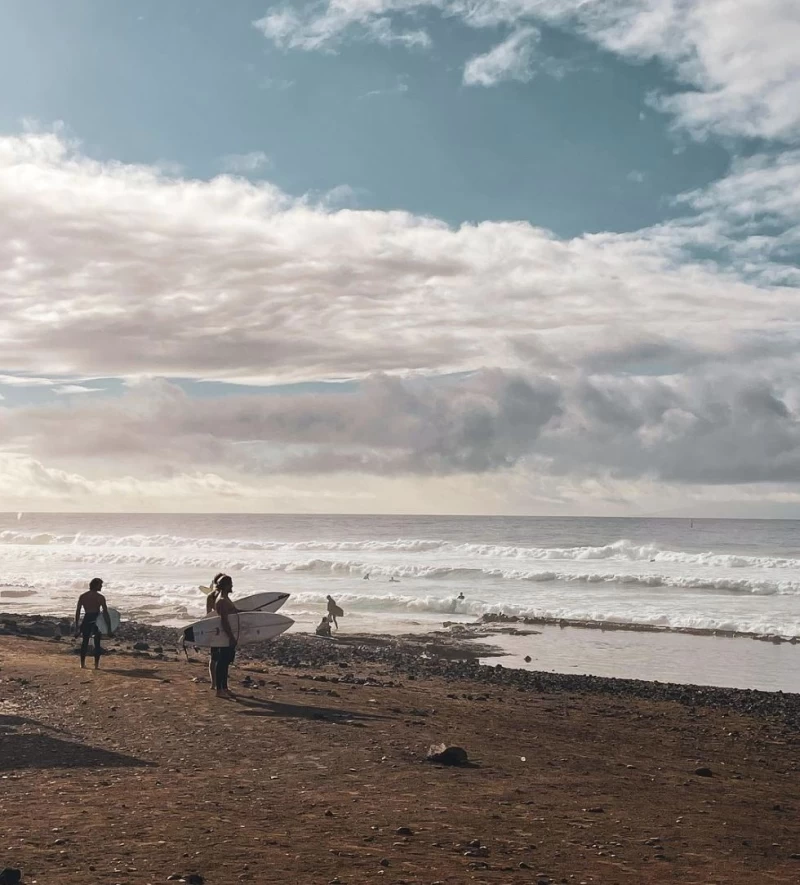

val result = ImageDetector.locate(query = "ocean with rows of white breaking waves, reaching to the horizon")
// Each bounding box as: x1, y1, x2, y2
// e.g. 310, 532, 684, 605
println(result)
0, 513, 800, 687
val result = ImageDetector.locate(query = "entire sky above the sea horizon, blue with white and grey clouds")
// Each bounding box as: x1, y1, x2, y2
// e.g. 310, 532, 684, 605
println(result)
0, 0, 800, 517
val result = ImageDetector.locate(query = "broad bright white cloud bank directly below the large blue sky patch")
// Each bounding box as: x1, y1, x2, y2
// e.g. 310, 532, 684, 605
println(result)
0, 128, 800, 383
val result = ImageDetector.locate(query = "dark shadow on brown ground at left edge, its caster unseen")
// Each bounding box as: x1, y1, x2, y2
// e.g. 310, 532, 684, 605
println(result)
0, 716, 154, 771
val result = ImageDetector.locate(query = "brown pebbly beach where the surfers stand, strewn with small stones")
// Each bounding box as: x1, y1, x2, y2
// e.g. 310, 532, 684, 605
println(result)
0, 619, 800, 885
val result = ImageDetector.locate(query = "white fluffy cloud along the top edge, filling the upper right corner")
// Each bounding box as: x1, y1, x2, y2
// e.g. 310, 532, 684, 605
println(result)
256, 0, 800, 139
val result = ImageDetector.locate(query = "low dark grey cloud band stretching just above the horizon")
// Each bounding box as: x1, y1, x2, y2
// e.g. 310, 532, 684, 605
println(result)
6, 369, 800, 485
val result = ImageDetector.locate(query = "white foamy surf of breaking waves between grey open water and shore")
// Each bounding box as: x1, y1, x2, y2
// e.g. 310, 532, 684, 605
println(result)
0, 515, 800, 636
